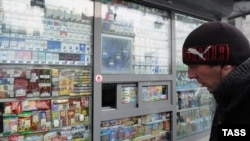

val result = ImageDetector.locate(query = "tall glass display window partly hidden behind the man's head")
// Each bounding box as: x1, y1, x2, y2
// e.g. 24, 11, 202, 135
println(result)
175, 13, 213, 139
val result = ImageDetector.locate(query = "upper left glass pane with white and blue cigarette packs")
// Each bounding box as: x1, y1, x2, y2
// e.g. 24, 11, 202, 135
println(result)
0, 0, 93, 66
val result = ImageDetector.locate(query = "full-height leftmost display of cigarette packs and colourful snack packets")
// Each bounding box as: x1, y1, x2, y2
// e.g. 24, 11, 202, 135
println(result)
0, 0, 93, 141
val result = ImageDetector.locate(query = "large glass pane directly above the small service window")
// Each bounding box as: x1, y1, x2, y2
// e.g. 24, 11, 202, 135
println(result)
101, 0, 171, 74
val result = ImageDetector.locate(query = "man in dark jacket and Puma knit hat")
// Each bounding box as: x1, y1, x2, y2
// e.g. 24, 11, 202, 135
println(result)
182, 21, 250, 141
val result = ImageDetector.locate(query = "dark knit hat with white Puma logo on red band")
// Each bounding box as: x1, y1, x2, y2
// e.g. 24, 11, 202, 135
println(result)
182, 21, 250, 65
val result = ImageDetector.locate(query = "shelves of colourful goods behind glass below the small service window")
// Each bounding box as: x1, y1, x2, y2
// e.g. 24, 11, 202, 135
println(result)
101, 112, 171, 141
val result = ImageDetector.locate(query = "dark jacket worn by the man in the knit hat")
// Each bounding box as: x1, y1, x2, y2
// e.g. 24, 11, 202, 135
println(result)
209, 58, 250, 141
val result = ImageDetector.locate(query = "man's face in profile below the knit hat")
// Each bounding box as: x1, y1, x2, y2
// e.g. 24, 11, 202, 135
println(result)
188, 65, 224, 93
